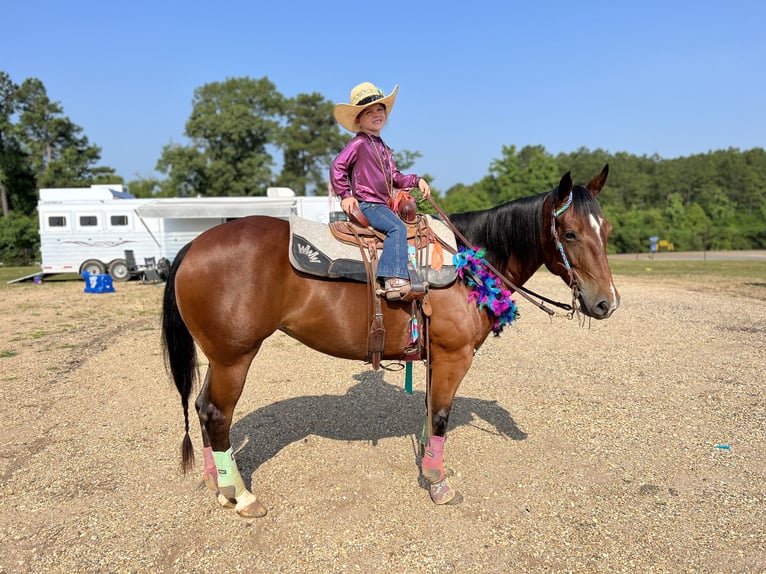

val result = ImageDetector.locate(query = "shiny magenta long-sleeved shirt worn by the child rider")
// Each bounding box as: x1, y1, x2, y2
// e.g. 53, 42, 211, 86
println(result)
330, 133, 420, 203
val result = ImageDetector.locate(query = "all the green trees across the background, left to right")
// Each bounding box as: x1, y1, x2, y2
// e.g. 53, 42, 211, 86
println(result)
0, 71, 766, 264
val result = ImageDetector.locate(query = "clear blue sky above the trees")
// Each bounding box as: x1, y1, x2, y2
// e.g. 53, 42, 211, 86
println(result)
0, 0, 766, 194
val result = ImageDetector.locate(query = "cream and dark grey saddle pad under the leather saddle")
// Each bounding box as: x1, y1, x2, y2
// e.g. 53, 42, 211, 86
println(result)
290, 215, 457, 287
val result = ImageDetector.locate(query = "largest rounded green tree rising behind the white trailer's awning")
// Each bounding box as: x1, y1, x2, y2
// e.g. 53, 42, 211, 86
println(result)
157, 77, 286, 196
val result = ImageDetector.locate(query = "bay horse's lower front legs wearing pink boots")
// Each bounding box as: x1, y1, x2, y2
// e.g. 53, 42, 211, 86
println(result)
420, 346, 473, 504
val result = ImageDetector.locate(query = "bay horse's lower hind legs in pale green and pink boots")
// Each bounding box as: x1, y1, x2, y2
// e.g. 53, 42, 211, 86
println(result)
195, 360, 266, 518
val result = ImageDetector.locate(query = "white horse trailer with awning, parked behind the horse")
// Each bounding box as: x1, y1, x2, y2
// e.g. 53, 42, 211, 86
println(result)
36, 185, 340, 281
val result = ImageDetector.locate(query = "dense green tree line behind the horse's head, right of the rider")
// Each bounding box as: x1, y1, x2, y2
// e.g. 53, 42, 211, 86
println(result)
442, 146, 766, 253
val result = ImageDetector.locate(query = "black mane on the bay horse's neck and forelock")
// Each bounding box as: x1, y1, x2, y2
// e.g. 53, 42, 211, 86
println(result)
449, 185, 602, 267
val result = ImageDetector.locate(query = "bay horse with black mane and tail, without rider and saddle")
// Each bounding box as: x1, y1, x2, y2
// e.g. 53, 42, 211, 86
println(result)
162, 166, 619, 517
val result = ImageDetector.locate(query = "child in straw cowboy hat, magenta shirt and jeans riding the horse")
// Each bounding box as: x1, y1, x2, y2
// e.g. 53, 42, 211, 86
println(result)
330, 82, 431, 301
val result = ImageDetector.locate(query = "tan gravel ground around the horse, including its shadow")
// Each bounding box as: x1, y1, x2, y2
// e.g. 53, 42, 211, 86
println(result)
0, 274, 766, 573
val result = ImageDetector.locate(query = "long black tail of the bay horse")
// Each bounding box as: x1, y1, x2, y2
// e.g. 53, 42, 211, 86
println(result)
162, 243, 197, 474
